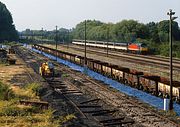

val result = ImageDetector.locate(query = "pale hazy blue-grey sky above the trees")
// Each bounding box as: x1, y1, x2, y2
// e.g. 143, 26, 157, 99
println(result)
0, 0, 180, 31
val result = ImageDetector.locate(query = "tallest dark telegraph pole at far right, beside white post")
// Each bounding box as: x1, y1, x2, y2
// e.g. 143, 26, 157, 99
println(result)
167, 9, 177, 110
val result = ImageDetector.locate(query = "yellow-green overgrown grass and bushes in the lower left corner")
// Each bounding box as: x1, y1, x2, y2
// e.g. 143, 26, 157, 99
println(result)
0, 82, 75, 127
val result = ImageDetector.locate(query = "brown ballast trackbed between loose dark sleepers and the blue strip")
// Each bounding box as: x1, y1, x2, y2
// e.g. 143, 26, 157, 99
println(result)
55, 63, 179, 127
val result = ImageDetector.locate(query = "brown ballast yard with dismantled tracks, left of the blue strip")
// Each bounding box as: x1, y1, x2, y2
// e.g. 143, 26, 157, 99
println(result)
0, 46, 180, 127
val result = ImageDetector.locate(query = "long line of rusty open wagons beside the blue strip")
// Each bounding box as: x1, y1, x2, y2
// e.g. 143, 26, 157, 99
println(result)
32, 45, 180, 103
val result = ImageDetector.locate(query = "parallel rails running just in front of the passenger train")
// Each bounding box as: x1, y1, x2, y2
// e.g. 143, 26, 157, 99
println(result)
59, 45, 180, 71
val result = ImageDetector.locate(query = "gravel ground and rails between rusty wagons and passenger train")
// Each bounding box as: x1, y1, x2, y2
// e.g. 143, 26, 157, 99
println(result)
44, 44, 180, 80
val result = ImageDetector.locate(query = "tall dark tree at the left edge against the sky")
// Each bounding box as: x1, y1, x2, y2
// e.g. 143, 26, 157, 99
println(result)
0, 2, 18, 41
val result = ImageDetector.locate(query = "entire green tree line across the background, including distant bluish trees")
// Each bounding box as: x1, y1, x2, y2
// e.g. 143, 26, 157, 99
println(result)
21, 20, 180, 57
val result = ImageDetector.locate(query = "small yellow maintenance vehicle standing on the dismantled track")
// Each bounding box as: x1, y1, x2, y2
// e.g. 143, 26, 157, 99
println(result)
39, 62, 54, 77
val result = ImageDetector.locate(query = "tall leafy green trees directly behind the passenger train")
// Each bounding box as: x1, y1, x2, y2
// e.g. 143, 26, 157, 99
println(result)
72, 20, 180, 43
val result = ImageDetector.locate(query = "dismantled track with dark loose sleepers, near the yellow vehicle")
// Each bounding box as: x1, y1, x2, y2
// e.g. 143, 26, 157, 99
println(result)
14, 45, 138, 127
